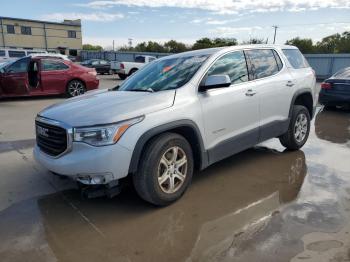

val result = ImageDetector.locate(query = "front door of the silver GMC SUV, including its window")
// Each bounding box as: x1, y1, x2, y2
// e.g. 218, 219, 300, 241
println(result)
199, 51, 259, 163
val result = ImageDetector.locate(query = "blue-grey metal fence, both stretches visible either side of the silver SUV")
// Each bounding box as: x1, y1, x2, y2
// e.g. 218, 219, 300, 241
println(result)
80, 51, 350, 79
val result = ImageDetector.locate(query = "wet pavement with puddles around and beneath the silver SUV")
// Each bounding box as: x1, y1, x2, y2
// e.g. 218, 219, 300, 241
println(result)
0, 89, 350, 261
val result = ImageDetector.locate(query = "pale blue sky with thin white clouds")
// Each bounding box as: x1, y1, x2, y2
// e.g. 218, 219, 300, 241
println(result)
0, 0, 350, 48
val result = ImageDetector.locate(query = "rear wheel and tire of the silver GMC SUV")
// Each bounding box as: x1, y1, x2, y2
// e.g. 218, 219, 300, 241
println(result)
279, 105, 310, 150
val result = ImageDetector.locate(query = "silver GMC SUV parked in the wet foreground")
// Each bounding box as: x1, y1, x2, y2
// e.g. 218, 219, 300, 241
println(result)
34, 45, 317, 205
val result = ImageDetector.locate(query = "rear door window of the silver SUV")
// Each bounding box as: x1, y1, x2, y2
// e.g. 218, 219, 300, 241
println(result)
245, 49, 279, 79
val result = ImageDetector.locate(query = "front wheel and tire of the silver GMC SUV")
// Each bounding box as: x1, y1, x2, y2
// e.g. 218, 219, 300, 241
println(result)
133, 133, 193, 206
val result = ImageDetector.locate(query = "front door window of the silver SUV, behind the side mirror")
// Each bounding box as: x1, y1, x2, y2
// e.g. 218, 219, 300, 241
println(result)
207, 51, 248, 84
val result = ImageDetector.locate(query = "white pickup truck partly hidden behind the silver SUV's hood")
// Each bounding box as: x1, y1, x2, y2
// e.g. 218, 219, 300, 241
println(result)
111, 55, 157, 80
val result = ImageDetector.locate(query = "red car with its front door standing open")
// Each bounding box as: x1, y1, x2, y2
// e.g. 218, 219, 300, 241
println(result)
0, 56, 99, 98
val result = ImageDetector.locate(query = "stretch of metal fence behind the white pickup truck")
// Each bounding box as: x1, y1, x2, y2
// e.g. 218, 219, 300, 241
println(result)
80, 51, 171, 62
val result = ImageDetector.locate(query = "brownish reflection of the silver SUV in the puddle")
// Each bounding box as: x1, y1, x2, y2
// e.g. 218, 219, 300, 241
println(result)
33, 148, 306, 261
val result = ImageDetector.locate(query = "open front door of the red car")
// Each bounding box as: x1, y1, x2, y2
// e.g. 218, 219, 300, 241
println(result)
1, 57, 30, 96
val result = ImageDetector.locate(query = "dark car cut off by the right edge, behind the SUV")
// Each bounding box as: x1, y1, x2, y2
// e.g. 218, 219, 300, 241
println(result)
319, 67, 350, 107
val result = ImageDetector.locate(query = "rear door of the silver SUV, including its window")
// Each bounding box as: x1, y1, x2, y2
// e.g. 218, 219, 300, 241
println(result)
245, 49, 294, 141
